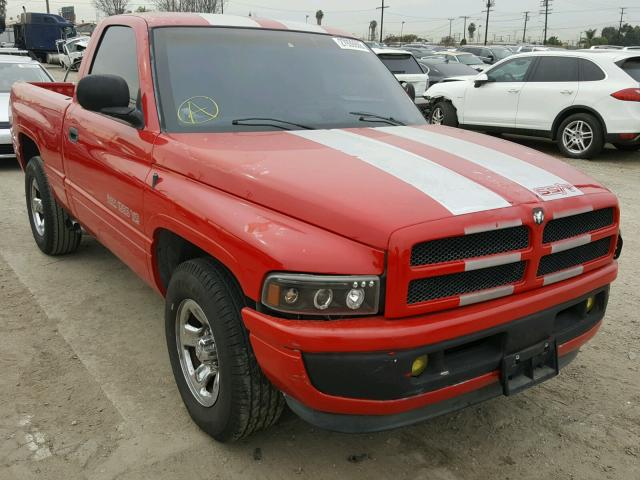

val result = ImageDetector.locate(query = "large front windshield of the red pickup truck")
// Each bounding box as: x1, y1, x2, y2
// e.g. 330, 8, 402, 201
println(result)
153, 27, 426, 132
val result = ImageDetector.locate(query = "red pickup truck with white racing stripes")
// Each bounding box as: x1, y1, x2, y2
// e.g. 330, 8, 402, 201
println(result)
11, 14, 622, 441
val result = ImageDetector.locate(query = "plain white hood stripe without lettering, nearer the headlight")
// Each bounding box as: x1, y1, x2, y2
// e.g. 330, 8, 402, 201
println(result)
289, 130, 511, 215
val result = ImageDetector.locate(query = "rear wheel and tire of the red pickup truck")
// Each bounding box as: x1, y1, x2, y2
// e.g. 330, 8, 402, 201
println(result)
25, 156, 82, 255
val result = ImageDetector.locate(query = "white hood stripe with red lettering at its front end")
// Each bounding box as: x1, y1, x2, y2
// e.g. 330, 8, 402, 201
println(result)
377, 127, 582, 200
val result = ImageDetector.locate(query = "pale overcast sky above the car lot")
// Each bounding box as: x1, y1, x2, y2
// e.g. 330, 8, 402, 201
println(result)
7, 0, 640, 42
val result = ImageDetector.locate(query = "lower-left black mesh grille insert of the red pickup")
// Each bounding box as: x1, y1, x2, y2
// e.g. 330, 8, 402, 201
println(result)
407, 262, 526, 305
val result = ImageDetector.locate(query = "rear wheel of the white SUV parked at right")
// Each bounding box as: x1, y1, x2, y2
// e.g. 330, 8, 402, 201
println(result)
558, 113, 604, 159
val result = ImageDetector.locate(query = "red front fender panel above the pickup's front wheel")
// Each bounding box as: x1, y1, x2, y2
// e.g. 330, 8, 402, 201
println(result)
144, 169, 385, 299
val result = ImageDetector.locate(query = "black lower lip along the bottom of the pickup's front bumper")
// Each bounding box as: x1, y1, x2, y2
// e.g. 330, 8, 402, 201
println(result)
285, 350, 578, 433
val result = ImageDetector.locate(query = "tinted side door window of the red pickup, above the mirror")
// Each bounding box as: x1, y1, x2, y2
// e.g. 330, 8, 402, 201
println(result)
89, 26, 140, 108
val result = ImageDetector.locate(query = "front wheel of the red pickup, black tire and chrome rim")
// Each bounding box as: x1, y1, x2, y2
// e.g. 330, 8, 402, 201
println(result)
165, 258, 284, 442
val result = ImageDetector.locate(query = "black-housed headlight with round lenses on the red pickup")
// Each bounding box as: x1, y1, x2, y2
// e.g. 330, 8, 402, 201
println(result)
262, 273, 380, 315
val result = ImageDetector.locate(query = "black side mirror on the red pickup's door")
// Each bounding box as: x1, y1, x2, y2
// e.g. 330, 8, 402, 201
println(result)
76, 75, 144, 128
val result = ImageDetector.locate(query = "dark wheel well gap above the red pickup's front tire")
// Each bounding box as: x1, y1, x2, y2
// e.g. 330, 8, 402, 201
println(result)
154, 229, 248, 305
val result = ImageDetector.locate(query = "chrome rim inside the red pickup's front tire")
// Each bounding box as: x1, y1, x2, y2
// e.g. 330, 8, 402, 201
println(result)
176, 299, 220, 407
